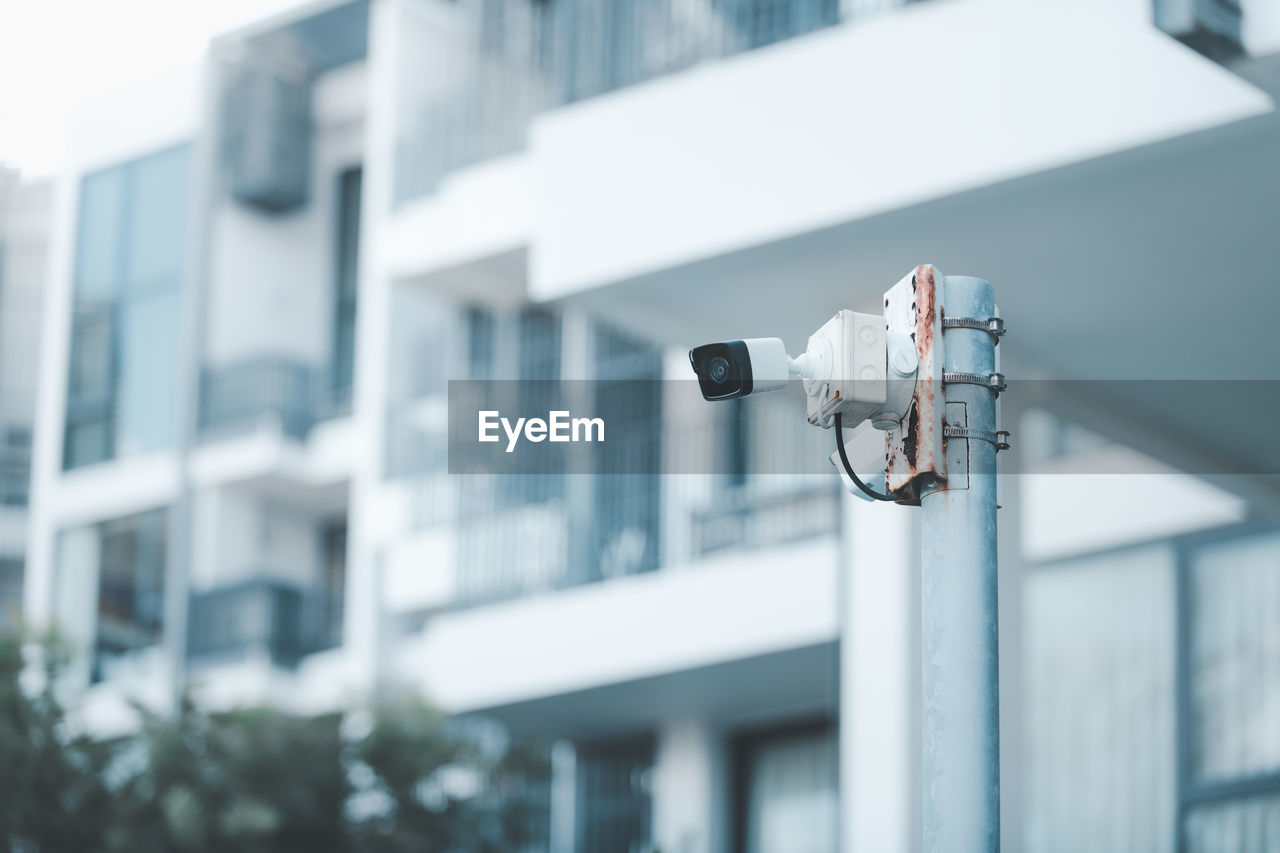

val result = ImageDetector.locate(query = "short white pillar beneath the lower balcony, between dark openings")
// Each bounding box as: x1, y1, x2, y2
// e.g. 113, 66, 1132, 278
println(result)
653, 720, 728, 853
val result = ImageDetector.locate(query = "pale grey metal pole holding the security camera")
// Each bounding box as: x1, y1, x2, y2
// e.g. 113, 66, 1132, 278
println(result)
920, 275, 1000, 853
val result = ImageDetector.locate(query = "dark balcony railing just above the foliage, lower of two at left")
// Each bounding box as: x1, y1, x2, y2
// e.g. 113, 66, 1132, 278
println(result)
187, 578, 334, 667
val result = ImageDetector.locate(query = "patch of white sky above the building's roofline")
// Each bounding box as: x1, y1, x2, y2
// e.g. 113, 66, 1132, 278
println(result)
0, 0, 300, 177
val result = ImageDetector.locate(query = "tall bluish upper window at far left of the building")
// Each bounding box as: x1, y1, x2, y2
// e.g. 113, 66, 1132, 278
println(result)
63, 146, 188, 469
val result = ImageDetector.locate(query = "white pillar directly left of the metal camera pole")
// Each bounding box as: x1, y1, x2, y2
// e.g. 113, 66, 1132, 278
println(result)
840, 496, 920, 853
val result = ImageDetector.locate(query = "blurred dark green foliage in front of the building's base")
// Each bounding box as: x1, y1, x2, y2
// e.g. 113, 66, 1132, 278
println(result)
0, 638, 549, 853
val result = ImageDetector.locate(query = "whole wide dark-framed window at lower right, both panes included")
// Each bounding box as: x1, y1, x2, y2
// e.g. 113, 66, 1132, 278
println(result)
1024, 530, 1280, 853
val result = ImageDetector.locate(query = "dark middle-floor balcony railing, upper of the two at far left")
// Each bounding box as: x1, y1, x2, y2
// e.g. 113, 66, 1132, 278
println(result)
200, 356, 351, 441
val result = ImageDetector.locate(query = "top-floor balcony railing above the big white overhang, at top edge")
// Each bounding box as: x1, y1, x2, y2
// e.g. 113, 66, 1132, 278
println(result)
396, 0, 870, 201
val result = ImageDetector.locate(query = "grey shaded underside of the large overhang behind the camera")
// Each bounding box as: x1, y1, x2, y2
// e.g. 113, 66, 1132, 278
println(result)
547, 105, 1280, 508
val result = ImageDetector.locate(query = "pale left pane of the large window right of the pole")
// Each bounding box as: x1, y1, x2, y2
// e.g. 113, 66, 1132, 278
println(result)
1023, 546, 1176, 853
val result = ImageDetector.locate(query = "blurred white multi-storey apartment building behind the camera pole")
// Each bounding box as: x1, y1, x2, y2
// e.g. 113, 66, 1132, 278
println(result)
23, 0, 1280, 853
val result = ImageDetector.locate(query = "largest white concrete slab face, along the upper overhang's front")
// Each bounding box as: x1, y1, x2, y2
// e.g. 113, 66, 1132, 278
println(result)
530, 0, 1272, 298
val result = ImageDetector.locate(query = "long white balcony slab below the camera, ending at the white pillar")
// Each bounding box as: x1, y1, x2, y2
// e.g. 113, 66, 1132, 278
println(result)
396, 539, 838, 711
